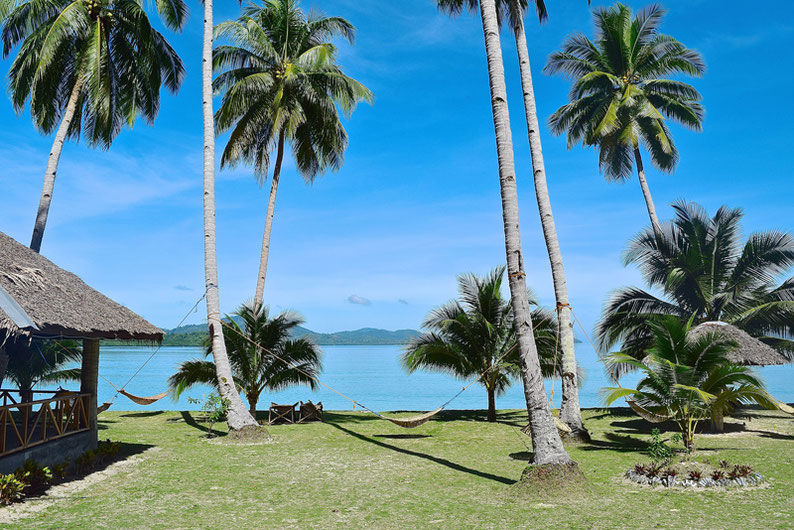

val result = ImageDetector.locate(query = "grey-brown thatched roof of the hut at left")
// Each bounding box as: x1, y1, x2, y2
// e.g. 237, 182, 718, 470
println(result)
0, 232, 163, 342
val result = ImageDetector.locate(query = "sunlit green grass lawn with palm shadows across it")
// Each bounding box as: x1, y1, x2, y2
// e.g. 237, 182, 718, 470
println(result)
0, 409, 794, 528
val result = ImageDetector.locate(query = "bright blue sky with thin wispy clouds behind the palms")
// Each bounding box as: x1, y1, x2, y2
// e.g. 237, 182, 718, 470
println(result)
0, 0, 794, 332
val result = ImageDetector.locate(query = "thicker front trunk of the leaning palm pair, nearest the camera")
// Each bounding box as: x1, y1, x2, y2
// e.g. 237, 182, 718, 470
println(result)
480, 0, 571, 464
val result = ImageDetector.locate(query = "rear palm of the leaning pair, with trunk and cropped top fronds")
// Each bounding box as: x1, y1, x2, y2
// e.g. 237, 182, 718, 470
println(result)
439, 0, 589, 440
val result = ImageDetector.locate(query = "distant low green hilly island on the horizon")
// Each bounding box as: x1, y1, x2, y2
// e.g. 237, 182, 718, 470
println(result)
102, 324, 419, 346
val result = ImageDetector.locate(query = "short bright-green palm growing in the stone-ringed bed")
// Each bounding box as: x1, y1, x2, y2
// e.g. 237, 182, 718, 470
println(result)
604, 316, 780, 451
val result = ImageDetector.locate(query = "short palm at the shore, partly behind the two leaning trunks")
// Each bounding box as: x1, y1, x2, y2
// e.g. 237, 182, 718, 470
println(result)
402, 266, 562, 422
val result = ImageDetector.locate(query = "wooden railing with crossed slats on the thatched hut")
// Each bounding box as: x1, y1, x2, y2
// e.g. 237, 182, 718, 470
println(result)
0, 390, 91, 456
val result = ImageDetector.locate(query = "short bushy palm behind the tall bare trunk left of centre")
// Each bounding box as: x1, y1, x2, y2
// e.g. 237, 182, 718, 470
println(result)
168, 304, 322, 416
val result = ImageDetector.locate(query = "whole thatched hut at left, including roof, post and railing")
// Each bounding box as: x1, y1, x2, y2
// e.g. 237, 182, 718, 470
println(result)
0, 232, 163, 472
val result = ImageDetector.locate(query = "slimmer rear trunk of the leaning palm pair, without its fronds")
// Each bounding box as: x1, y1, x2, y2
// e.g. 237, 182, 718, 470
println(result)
515, 16, 590, 440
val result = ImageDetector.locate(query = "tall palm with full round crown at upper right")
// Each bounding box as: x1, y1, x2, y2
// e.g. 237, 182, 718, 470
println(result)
544, 4, 706, 231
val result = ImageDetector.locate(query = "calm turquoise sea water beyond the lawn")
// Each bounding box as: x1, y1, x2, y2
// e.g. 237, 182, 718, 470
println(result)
76, 344, 794, 411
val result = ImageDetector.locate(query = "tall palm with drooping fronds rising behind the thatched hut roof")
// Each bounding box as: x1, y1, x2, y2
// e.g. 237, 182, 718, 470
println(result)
2, 0, 187, 252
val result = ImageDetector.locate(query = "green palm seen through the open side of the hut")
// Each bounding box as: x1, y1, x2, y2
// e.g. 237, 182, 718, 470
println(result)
5, 340, 82, 402
